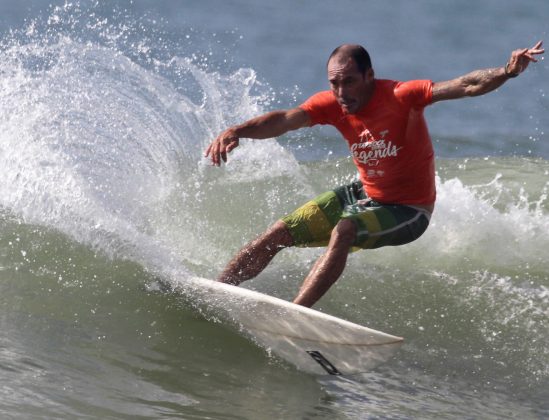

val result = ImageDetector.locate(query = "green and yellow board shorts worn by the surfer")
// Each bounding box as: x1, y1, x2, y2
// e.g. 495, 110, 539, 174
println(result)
282, 181, 431, 249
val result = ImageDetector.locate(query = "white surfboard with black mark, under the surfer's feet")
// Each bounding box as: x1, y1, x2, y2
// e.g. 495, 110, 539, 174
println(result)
176, 278, 403, 375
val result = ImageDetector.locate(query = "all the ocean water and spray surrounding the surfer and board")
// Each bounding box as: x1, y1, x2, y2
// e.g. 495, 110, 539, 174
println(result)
0, 0, 549, 419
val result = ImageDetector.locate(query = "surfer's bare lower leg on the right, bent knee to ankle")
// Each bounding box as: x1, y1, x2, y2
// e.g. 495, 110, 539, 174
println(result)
294, 219, 356, 307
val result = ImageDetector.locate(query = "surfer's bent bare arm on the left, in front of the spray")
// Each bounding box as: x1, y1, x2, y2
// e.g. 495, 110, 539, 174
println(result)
205, 108, 310, 166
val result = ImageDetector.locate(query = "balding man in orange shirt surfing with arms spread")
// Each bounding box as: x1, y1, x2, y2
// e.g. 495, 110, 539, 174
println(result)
205, 41, 544, 307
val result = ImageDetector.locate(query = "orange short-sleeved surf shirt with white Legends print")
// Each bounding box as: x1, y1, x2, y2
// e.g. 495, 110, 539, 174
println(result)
300, 79, 436, 205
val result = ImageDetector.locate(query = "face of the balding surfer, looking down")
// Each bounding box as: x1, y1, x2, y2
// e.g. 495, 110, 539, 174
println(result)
328, 57, 374, 114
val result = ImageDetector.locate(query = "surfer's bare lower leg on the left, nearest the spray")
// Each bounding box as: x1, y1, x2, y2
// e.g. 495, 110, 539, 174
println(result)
217, 220, 294, 285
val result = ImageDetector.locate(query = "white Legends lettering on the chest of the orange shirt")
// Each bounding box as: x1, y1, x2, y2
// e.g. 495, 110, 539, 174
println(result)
351, 129, 402, 171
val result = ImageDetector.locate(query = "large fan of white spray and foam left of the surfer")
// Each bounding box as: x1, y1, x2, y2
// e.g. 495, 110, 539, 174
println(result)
0, 22, 298, 280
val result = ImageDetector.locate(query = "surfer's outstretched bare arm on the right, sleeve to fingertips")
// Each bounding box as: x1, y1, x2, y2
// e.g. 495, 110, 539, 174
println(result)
432, 41, 545, 103
